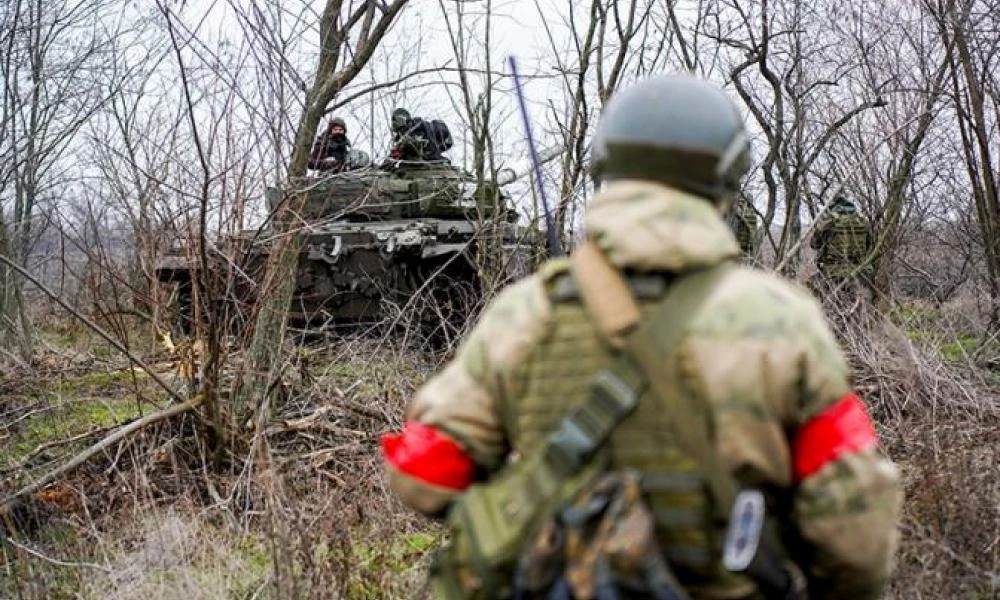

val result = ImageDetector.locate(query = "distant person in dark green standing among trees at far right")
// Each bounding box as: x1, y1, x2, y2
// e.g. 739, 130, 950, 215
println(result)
809, 196, 872, 287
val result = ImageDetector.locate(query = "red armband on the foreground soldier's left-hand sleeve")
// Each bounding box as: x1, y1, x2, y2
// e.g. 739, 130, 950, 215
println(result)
382, 422, 475, 490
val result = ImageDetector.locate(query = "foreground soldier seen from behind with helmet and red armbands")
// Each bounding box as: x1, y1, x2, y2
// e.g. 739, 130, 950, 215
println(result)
383, 76, 900, 600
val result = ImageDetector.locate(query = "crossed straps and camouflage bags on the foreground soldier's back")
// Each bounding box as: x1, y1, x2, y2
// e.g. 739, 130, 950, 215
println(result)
431, 244, 803, 600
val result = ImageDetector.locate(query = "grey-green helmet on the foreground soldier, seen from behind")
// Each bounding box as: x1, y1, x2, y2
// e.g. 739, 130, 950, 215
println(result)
591, 75, 750, 203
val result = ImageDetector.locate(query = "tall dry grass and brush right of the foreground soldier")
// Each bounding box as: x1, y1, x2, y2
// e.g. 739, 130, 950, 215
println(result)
820, 299, 1000, 600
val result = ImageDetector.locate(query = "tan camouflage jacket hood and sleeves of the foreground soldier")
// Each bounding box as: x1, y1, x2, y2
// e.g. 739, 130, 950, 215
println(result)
389, 181, 899, 599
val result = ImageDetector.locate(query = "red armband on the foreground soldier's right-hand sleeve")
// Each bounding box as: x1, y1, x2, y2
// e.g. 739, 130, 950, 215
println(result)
792, 393, 878, 481
